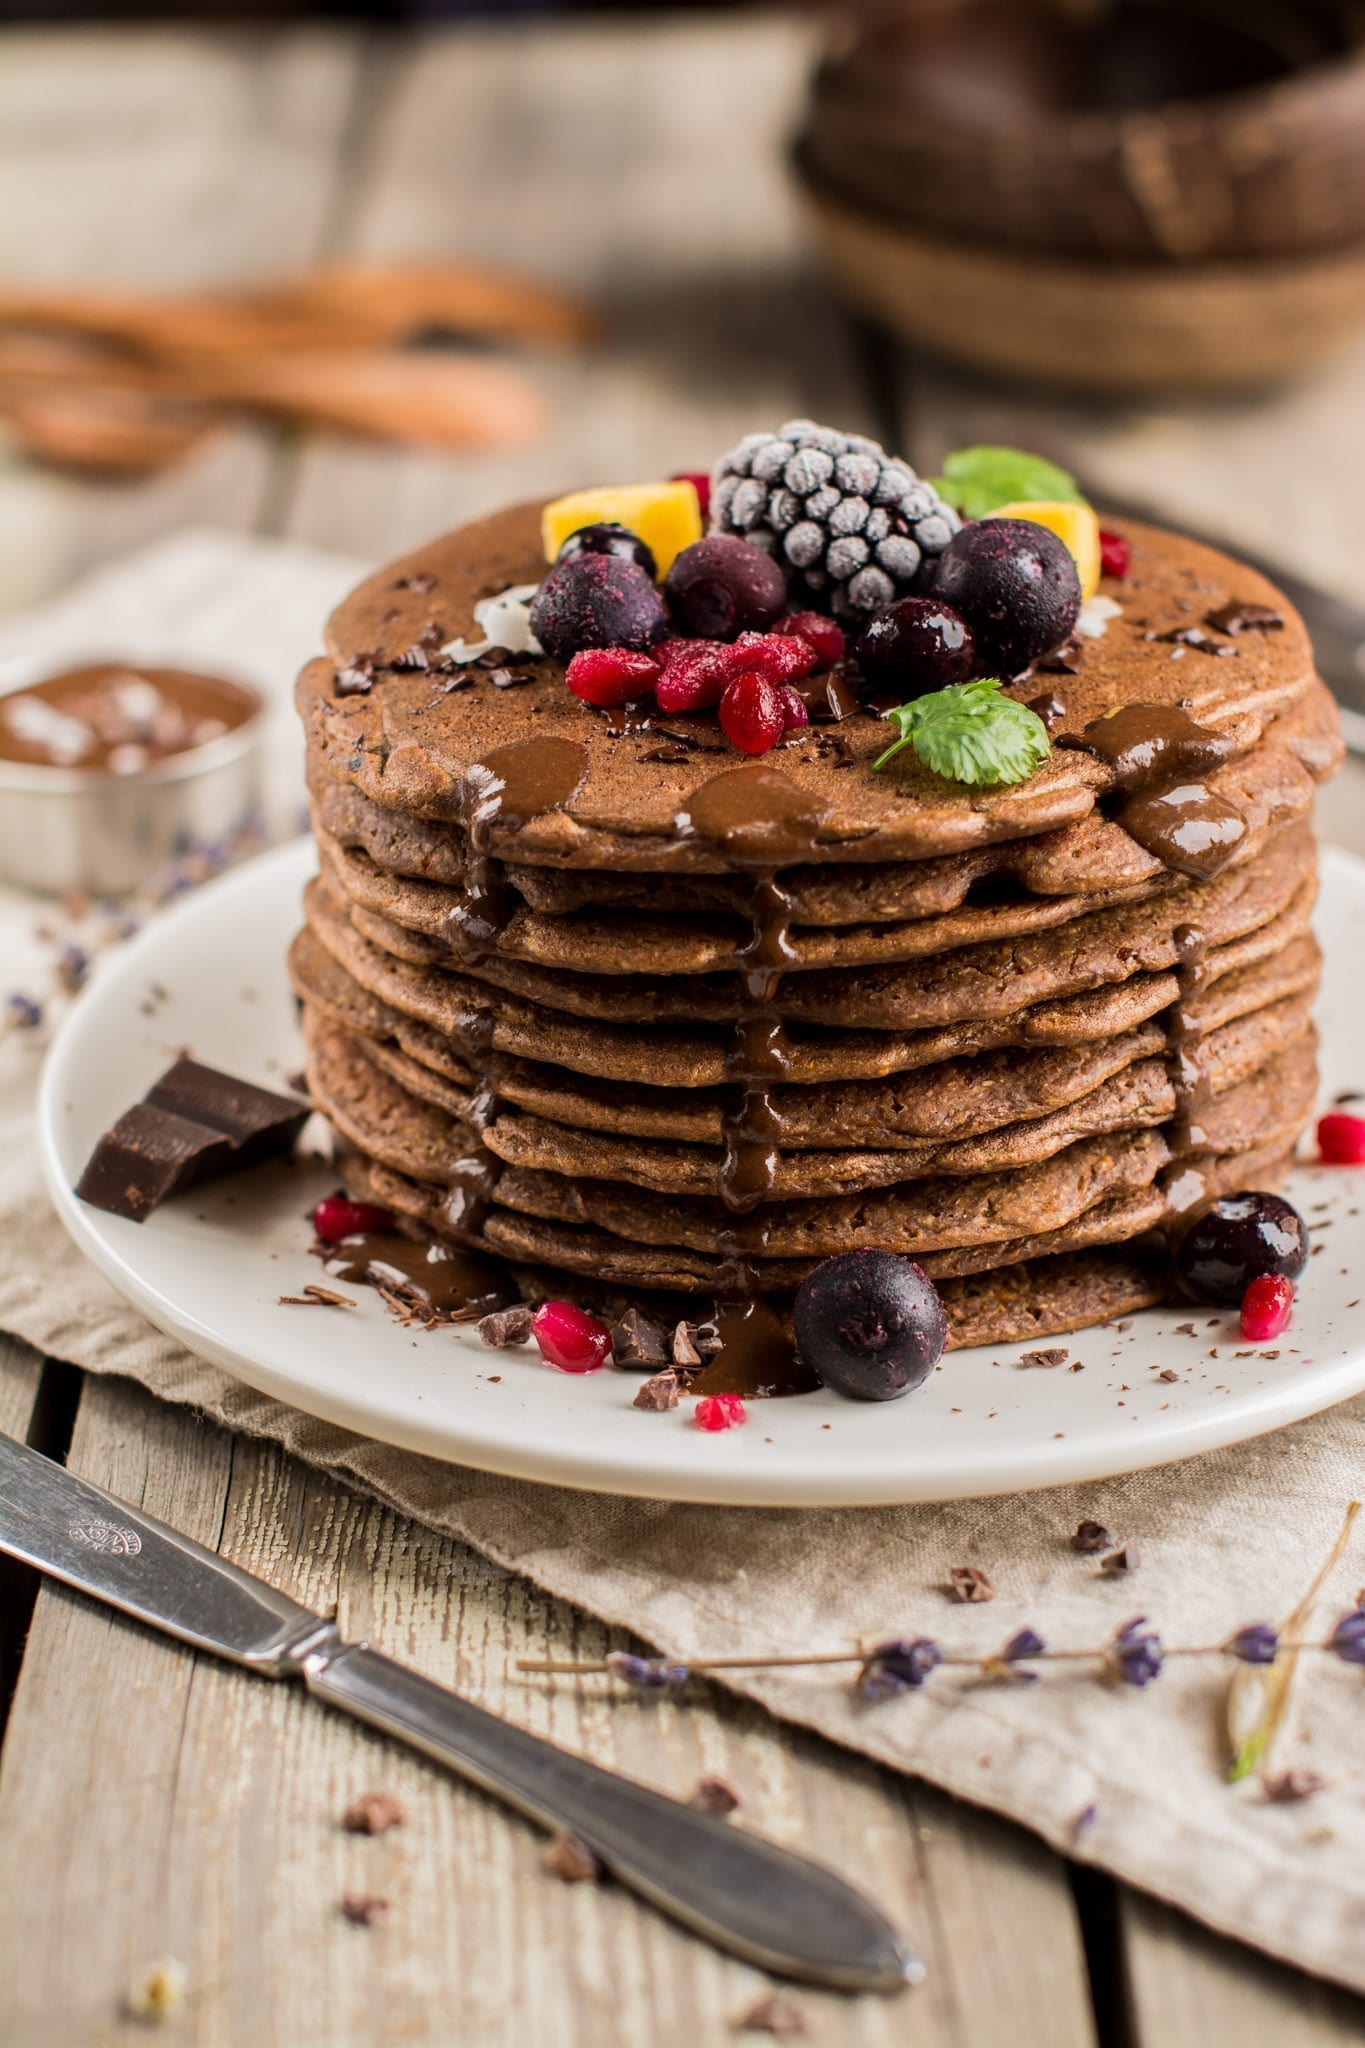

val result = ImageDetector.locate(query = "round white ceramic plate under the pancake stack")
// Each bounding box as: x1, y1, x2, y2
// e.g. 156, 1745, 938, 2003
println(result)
41, 842, 1365, 1505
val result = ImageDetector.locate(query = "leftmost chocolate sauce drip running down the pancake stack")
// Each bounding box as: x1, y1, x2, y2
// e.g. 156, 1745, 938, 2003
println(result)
444, 735, 587, 1245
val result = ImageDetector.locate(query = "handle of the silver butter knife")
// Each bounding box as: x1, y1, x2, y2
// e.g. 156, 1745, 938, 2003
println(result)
303, 1645, 919, 1991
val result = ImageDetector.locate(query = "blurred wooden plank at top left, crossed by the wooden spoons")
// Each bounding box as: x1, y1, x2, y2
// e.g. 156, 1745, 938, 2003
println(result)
0, 29, 358, 610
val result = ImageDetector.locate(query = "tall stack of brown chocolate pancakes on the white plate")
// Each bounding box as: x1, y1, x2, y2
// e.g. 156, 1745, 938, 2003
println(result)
291, 506, 1340, 1346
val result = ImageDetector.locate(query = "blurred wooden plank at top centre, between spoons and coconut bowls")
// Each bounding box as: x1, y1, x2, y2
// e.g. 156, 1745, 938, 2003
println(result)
289, 16, 868, 559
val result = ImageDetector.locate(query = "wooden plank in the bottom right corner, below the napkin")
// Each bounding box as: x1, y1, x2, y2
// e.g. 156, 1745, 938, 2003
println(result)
1119, 1892, 1365, 2048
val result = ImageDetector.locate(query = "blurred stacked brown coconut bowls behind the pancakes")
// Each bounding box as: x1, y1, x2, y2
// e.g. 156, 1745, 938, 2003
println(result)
798, 0, 1365, 391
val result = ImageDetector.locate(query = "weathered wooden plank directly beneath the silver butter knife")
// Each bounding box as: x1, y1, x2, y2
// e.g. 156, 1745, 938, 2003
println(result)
0, 1380, 1093, 2048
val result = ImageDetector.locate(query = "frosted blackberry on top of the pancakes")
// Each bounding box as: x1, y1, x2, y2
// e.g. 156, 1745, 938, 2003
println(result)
710, 420, 962, 616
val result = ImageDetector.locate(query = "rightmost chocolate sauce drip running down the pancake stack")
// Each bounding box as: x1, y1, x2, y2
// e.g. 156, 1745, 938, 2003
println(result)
1058, 705, 1246, 1233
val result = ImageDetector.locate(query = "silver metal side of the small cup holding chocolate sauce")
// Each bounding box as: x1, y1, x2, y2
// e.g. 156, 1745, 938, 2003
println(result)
0, 664, 266, 897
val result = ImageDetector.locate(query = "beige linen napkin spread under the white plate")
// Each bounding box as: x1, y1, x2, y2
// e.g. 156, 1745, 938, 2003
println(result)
0, 541, 1365, 1991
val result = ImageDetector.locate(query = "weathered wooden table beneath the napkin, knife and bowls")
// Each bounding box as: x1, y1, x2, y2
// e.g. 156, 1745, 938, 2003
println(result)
0, 18, 1365, 2048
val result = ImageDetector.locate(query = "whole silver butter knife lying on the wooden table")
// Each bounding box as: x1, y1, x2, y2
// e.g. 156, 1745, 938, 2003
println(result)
0, 1434, 923, 1991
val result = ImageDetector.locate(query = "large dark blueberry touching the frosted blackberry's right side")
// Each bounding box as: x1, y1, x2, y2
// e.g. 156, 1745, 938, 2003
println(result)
933, 518, 1081, 680
